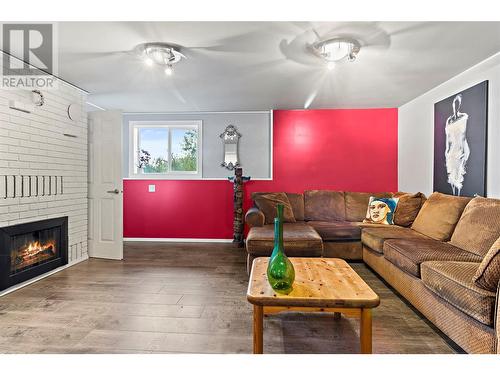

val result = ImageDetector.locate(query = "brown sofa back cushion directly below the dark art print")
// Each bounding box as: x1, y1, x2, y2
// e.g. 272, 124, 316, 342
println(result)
411, 193, 471, 241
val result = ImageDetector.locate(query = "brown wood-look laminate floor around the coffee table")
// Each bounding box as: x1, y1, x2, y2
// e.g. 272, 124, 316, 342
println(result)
0, 242, 455, 353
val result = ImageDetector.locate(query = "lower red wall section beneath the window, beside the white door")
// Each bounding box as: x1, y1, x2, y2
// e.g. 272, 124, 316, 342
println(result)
123, 180, 233, 238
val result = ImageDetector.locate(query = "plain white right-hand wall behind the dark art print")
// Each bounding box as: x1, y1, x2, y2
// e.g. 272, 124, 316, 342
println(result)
398, 53, 500, 198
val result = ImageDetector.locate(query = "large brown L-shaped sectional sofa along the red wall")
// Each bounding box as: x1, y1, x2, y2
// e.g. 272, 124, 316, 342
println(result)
246, 190, 500, 353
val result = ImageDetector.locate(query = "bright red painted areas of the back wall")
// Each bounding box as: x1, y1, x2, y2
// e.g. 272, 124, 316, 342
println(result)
124, 108, 398, 238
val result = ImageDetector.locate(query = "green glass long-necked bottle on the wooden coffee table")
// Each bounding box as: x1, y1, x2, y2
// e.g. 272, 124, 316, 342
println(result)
267, 204, 295, 294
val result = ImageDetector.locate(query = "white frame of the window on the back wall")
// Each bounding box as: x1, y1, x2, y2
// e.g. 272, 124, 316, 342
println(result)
129, 120, 203, 180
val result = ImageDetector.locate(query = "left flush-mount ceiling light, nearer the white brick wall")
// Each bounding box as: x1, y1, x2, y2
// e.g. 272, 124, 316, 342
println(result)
135, 42, 186, 76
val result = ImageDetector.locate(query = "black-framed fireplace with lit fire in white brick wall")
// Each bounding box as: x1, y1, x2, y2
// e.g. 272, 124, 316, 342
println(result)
0, 216, 68, 290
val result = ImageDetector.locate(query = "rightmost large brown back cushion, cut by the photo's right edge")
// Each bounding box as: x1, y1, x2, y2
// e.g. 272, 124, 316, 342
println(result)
450, 197, 500, 256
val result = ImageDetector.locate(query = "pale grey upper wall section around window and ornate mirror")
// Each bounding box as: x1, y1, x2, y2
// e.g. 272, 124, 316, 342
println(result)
123, 111, 272, 179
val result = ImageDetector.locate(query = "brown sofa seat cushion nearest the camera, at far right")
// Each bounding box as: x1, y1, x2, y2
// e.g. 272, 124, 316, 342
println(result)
422, 261, 496, 326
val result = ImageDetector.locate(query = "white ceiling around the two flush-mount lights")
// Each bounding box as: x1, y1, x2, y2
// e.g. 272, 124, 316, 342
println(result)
59, 22, 500, 112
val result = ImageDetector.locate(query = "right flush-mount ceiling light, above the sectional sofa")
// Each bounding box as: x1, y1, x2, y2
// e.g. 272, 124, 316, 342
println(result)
311, 38, 361, 69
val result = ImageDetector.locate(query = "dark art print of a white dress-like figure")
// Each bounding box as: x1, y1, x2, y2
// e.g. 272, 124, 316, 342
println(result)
434, 81, 488, 197
